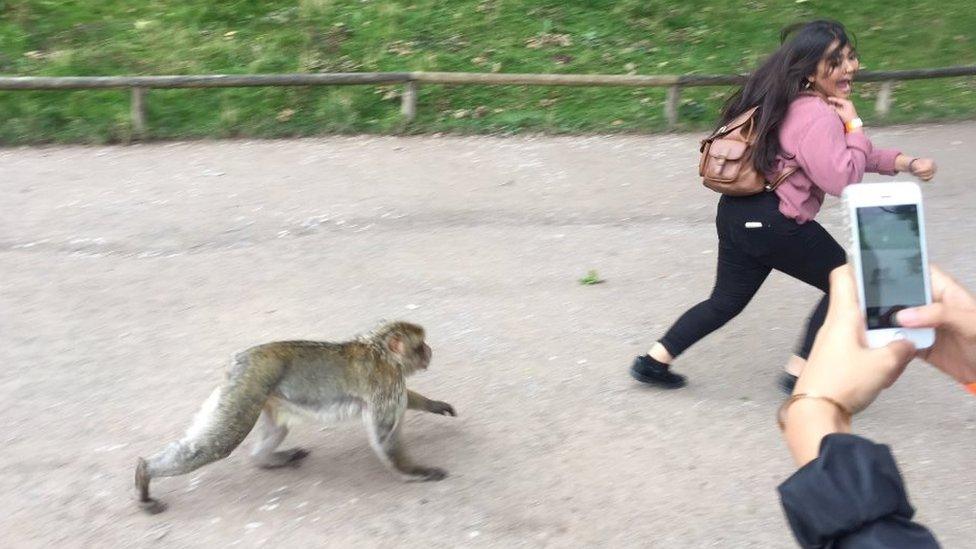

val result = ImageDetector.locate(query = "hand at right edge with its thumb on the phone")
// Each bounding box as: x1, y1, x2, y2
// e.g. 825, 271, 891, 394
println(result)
896, 264, 976, 384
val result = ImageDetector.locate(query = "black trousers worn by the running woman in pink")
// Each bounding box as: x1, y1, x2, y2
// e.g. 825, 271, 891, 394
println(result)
660, 193, 847, 358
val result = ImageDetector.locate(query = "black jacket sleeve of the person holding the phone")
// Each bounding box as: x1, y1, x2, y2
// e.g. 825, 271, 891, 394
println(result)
779, 433, 939, 549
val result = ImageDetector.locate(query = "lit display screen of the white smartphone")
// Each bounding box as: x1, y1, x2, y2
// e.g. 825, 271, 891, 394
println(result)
857, 204, 925, 330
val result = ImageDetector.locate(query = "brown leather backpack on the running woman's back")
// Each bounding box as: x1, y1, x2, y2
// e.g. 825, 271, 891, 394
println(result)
698, 107, 796, 196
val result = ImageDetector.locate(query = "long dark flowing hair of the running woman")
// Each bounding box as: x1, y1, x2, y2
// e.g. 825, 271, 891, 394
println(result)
719, 20, 853, 173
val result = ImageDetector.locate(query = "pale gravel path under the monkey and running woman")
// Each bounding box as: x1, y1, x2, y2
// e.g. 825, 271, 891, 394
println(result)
0, 123, 976, 548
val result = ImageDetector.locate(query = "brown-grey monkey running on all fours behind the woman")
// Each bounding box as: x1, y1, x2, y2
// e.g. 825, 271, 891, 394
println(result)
135, 322, 456, 513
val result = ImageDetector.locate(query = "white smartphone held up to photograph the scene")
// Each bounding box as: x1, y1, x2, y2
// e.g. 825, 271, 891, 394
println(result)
843, 182, 935, 349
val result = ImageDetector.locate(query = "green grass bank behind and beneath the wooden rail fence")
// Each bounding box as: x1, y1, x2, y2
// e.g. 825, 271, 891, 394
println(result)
0, 0, 976, 144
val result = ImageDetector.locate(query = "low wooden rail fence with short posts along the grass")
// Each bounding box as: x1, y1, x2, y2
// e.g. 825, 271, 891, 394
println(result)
0, 65, 976, 136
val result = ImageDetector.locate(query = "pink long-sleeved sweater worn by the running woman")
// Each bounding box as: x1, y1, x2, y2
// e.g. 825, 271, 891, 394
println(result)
767, 95, 900, 223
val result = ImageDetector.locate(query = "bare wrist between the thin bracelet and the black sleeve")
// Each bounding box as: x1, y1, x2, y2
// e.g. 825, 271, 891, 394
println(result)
783, 398, 851, 467
